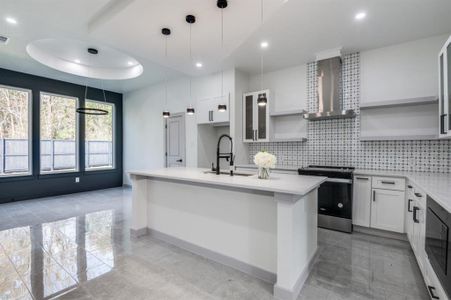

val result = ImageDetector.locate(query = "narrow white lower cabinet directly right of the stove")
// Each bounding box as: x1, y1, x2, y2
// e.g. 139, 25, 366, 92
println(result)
352, 176, 371, 227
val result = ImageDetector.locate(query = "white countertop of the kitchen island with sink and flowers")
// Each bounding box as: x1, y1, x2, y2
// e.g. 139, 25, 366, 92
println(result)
128, 168, 327, 196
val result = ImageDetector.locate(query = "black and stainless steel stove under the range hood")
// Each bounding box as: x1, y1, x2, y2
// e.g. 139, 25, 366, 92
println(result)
298, 165, 354, 233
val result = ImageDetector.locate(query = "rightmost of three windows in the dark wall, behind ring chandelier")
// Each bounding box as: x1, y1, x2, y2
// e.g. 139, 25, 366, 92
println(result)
85, 100, 114, 171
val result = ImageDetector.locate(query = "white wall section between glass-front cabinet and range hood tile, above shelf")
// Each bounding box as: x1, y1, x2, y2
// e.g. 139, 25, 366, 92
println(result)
249, 64, 307, 111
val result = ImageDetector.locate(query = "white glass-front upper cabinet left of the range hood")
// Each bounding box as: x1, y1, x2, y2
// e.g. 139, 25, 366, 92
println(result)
243, 90, 271, 142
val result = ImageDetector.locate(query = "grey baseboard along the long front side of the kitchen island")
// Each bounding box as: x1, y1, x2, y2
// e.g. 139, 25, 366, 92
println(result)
147, 228, 277, 284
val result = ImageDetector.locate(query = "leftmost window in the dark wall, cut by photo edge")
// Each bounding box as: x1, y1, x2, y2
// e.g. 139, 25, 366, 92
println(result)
0, 86, 31, 177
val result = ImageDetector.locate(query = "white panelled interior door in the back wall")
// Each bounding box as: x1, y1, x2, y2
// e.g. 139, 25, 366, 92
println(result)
166, 114, 186, 168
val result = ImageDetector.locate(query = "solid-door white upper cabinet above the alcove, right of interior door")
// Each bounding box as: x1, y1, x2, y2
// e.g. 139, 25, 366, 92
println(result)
196, 95, 230, 125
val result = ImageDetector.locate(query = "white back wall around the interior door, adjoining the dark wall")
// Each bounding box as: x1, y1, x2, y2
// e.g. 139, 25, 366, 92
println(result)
123, 70, 235, 184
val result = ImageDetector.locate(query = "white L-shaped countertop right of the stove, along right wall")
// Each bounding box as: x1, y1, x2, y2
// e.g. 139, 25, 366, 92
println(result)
354, 170, 451, 212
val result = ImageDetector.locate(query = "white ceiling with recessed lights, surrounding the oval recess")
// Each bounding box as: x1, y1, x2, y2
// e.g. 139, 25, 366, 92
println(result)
0, 0, 451, 92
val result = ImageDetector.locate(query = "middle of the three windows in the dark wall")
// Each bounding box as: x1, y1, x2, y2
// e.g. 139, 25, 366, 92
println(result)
40, 93, 78, 174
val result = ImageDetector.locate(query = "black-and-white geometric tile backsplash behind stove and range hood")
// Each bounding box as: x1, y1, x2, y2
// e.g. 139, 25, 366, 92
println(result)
249, 53, 451, 173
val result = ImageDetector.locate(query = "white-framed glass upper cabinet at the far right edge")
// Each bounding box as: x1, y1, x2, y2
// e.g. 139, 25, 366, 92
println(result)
438, 37, 451, 138
